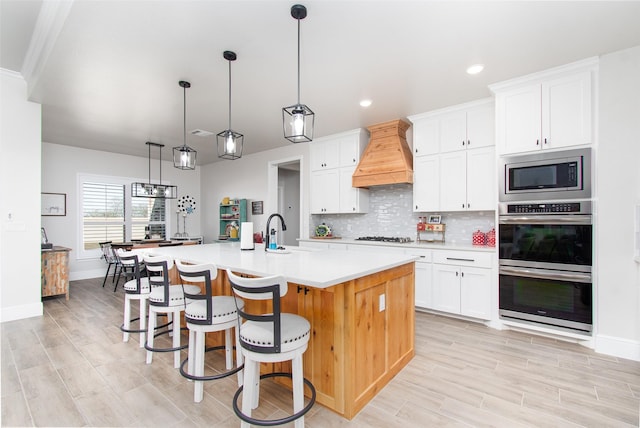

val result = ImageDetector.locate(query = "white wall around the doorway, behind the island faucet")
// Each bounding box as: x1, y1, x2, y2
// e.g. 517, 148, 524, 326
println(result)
201, 143, 309, 243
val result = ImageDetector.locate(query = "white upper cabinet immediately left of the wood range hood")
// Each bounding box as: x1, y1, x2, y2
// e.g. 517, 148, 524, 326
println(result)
309, 129, 369, 214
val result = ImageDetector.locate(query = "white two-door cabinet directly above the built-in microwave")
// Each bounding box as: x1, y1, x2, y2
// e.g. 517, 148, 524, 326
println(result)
490, 59, 597, 154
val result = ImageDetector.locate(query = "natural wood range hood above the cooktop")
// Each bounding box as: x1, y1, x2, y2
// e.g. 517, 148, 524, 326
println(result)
351, 119, 413, 187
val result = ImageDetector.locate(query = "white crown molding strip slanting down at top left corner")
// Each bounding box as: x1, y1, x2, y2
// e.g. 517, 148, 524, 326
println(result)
22, 0, 74, 96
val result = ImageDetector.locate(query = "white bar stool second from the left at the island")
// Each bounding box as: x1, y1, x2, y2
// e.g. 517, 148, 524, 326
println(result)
144, 255, 200, 368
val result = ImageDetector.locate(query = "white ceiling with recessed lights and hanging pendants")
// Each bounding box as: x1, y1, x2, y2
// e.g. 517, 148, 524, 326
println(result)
0, 0, 640, 165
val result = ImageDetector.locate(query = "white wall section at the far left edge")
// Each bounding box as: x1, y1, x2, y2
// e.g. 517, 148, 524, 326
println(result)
0, 69, 42, 322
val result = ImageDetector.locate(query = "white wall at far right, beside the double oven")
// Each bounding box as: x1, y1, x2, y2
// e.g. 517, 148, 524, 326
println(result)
596, 46, 640, 360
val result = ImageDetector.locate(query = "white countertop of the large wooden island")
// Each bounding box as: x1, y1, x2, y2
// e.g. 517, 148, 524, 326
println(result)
149, 242, 416, 288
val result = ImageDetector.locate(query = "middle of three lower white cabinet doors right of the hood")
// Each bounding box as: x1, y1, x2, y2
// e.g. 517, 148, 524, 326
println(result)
440, 152, 467, 211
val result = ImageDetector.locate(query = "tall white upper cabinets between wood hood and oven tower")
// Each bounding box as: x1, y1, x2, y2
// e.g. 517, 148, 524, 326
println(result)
409, 99, 497, 212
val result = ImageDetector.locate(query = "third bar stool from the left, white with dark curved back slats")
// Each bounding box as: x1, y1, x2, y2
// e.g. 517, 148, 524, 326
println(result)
175, 260, 244, 403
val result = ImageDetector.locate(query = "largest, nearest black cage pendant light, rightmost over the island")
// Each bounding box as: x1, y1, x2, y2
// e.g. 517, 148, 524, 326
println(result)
282, 4, 314, 143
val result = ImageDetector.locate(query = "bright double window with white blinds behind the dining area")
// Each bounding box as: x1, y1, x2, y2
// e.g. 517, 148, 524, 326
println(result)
77, 174, 168, 259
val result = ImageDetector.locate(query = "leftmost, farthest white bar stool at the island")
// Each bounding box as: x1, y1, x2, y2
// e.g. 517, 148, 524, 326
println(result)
118, 250, 151, 348
